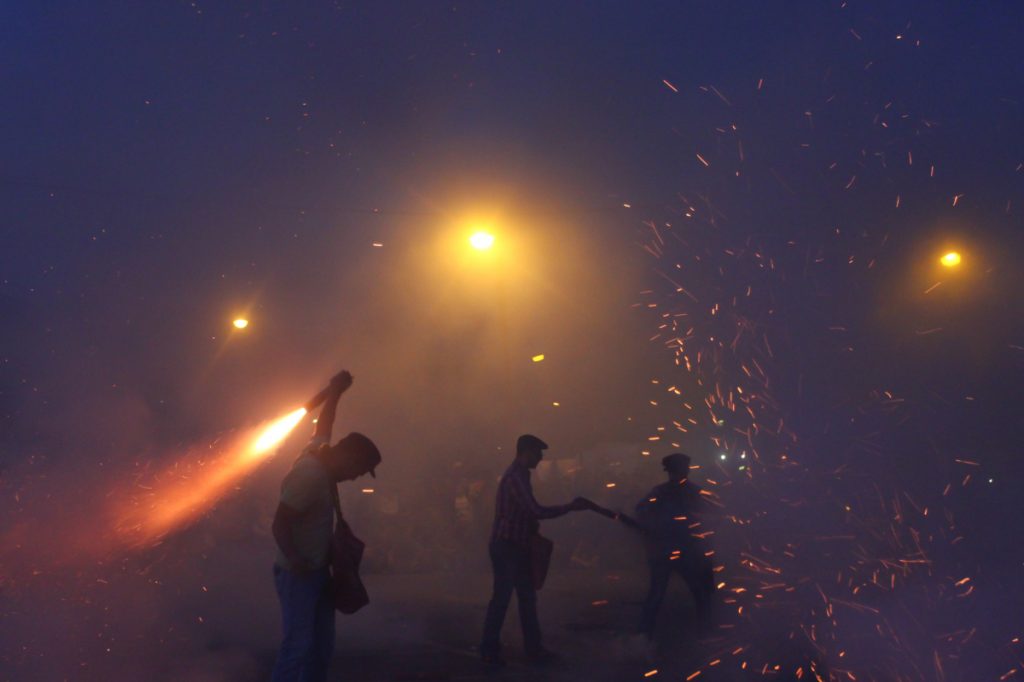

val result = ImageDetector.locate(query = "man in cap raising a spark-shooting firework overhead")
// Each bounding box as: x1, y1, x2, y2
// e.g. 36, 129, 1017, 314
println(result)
272, 372, 381, 682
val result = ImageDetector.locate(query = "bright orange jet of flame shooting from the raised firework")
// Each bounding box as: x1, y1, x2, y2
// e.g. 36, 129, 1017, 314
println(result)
115, 408, 306, 547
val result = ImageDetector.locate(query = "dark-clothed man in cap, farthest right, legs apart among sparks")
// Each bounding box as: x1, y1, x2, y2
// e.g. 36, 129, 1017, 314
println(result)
636, 453, 715, 638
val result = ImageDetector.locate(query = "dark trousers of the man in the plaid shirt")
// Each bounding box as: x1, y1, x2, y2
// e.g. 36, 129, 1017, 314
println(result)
480, 540, 543, 655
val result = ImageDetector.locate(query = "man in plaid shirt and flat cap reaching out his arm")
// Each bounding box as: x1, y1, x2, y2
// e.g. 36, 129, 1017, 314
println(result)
480, 434, 592, 666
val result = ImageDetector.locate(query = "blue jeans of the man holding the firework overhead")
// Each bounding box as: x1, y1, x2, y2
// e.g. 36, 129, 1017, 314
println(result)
271, 565, 334, 682
